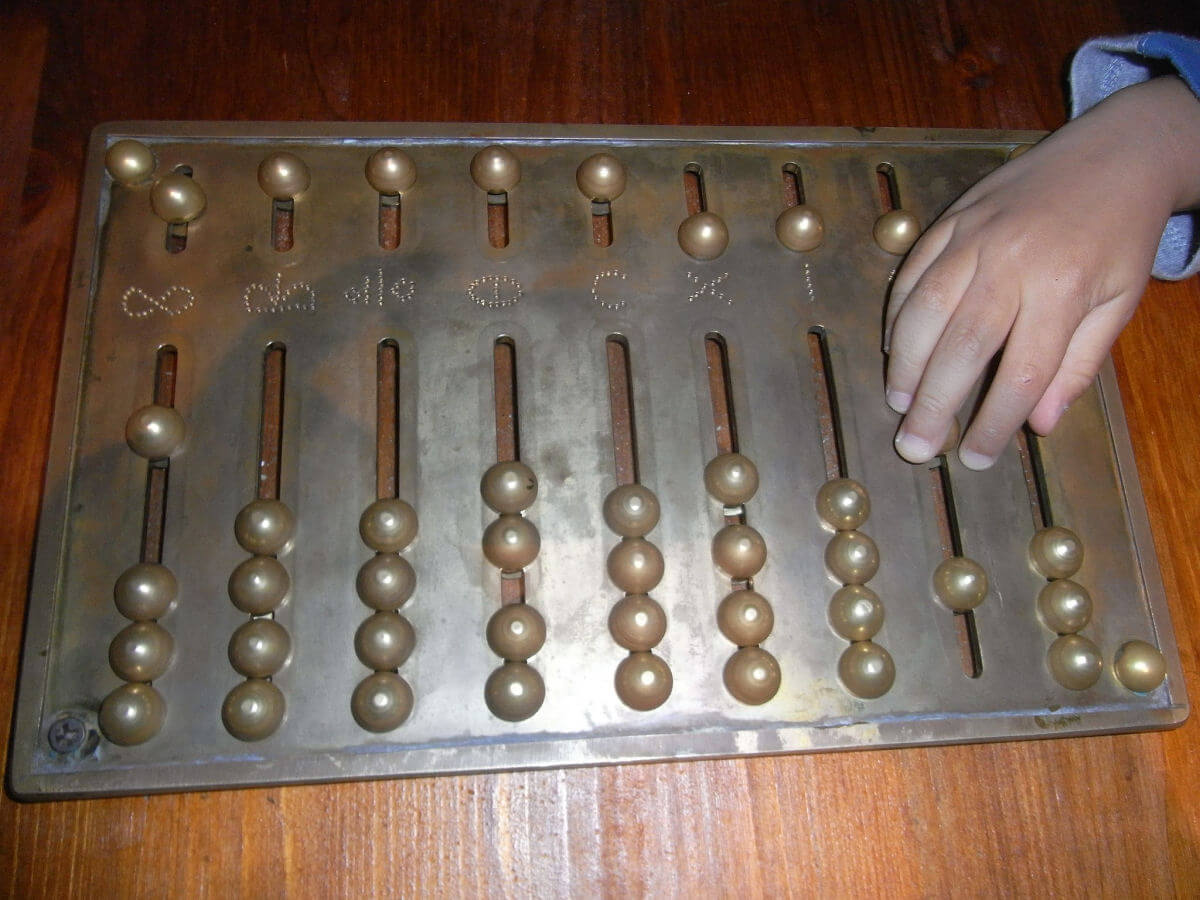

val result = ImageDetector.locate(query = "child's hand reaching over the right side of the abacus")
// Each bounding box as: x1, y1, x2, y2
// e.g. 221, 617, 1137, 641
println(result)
884, 78, 1200, 469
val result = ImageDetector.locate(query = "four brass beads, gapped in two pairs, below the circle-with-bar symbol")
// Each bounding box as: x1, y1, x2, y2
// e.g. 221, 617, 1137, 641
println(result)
479, 468, 546, 722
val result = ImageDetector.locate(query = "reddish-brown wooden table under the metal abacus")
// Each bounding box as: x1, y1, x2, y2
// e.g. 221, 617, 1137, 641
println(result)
0, 0, 1200, 896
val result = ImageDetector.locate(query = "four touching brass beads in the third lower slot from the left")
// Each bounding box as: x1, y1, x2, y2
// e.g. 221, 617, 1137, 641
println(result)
350, 497, 418, 733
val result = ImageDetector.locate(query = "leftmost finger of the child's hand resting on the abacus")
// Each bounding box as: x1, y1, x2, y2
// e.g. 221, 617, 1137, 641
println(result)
884, 252, 978, 413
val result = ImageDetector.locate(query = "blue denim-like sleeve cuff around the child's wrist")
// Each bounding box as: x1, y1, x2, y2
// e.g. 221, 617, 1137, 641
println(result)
1070, 31, 1200, 281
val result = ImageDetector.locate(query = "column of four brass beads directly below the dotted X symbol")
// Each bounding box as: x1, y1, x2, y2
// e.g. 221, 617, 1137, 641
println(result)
704, 452, 782, 706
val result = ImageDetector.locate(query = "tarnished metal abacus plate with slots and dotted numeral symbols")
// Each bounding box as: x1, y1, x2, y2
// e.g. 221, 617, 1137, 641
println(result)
10, 122, 1188, 797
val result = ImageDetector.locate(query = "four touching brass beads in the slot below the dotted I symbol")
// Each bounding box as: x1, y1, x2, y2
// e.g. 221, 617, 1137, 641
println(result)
816, 478, 896, 700
